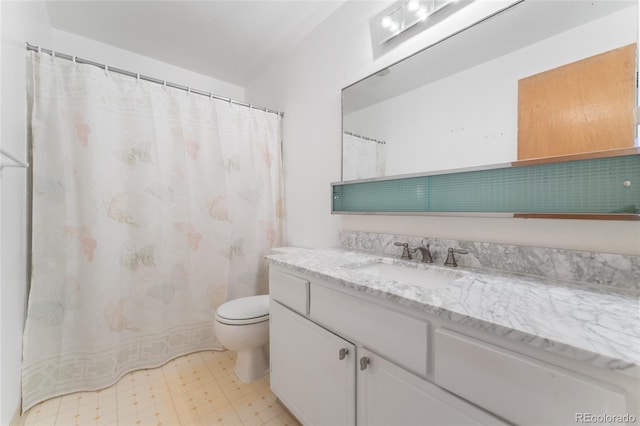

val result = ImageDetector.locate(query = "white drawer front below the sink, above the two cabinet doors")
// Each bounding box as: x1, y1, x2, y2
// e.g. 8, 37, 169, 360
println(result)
309, 283, 428, 376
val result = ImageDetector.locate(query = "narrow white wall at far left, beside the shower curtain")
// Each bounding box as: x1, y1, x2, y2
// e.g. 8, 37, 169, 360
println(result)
0, 1, 51, 425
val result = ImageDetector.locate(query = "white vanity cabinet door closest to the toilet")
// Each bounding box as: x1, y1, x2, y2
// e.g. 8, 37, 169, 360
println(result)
269, 302, 356, 426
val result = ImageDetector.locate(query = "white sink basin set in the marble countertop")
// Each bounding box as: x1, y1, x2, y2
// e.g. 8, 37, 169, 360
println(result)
354, 261, 463, 289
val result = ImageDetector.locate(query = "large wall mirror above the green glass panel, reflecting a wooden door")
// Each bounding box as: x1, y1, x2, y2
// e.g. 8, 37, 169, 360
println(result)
342, 0, 638, 181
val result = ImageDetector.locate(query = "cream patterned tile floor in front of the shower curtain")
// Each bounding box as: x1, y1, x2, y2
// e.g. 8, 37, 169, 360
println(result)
23, 351, 298, 426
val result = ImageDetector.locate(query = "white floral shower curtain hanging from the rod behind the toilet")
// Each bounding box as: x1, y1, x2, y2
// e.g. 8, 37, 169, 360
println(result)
22, 53, 283, 410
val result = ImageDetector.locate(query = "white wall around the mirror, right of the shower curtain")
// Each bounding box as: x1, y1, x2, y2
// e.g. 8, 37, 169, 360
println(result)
247, 1, 640, 255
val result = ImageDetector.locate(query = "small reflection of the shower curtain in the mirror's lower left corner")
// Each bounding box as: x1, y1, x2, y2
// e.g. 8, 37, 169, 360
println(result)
342, 132, 387, 180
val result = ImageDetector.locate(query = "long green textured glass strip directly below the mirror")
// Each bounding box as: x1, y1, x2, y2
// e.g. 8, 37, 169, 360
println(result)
333, 155, 640, 213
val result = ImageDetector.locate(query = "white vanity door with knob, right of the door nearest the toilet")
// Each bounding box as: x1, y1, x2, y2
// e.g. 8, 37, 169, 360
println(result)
357, 347, 504, 426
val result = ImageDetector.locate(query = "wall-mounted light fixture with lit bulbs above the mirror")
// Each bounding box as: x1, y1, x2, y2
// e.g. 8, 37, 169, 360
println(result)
370, 0, 473, 52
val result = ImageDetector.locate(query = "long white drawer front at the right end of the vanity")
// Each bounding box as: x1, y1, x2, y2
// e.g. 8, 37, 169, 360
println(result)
434, 329, 627, 425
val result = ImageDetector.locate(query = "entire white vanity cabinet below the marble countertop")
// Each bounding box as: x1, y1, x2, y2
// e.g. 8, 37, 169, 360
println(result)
270, 265, 640, 426
